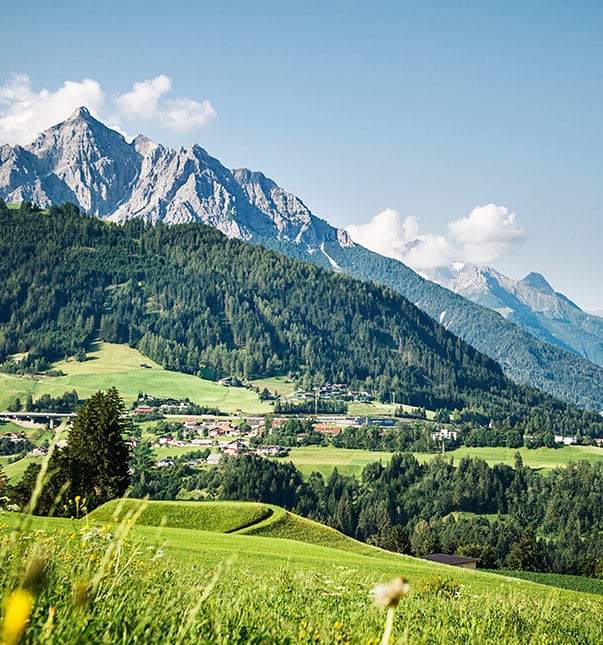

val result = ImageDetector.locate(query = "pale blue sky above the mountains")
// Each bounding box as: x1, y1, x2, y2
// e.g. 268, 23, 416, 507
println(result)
0, 0, 603, 309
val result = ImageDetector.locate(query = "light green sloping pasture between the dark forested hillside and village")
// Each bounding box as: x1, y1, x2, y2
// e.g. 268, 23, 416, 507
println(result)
0, 343, 271, 413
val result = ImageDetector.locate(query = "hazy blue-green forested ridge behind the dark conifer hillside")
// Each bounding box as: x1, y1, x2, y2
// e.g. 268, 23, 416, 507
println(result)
258, 237, 603, 410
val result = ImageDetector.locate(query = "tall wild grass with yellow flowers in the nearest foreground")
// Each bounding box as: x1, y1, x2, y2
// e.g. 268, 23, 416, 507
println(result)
0, 506, 603, 645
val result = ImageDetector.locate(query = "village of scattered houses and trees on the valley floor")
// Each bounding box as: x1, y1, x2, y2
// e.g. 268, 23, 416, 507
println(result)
0, 374, 603, 476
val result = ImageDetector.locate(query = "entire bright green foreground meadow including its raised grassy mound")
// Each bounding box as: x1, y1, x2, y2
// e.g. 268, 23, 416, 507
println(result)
0, 500, 603, 645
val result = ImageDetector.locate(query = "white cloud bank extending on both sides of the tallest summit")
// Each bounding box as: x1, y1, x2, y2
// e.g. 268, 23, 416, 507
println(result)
0, 74, 217, 144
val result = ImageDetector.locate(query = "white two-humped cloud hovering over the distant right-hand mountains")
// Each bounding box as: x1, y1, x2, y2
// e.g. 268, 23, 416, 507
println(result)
346, 204, 524, 271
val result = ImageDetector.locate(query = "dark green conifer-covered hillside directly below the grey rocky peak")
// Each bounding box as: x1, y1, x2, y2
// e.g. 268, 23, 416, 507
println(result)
0, 203, 603, 435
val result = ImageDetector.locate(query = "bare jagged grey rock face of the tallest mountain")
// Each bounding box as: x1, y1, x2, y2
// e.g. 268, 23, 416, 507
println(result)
0, 107, 337, 248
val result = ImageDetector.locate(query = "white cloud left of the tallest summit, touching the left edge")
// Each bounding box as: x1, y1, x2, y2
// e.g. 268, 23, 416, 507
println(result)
0, 74, 104, 144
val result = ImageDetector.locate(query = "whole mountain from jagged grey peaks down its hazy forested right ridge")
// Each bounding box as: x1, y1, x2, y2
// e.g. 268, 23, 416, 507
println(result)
0, 108, 603, 410
